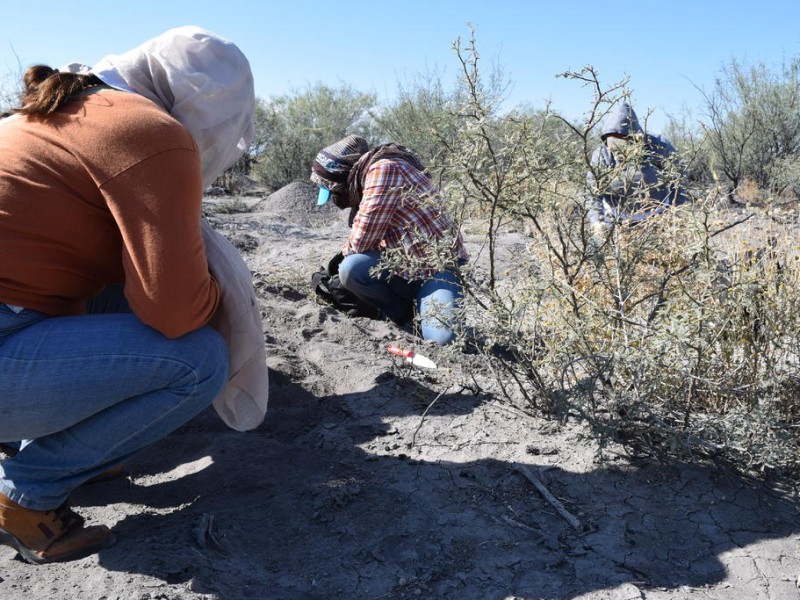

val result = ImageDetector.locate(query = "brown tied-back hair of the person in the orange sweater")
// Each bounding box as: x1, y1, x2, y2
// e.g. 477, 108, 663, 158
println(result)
14, 65, 103, 116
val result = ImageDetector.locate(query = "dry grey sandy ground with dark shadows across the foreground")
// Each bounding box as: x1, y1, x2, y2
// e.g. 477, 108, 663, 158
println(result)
0, 184, 800, 600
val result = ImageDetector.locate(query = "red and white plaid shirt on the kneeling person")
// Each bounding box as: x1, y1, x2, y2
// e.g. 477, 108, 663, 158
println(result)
343, 159, 469, 279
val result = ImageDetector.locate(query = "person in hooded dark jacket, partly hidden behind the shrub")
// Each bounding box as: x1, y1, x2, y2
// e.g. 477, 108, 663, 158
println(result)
586, 102, 687, 233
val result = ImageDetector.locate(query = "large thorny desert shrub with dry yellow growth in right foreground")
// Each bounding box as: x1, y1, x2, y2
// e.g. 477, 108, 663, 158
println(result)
424, 38, 800, 478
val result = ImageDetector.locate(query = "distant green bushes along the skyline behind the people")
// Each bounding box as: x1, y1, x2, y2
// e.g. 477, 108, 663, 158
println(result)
241, 38, 800, 211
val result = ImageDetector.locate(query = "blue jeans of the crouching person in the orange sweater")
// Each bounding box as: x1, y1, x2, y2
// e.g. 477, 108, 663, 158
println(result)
0, 288, 228, 510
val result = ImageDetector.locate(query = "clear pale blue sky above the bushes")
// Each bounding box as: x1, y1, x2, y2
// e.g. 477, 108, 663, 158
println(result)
0, 0, 800, 131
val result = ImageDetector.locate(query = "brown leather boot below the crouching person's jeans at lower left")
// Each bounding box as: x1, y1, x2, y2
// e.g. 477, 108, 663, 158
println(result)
0, 493, 114, 565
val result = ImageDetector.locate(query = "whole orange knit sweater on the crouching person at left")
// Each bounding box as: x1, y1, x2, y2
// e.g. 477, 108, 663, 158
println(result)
0, 90, 219, 337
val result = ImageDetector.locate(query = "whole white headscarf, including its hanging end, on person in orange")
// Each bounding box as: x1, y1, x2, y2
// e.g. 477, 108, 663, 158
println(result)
90, 26, 269, 431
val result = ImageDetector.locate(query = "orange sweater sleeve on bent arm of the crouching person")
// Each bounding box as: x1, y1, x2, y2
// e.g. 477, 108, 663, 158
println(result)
101, 148, 220, 338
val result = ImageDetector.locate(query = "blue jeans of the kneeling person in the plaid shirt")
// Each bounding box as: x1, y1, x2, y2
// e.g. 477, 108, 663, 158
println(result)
339, 252, 463, 346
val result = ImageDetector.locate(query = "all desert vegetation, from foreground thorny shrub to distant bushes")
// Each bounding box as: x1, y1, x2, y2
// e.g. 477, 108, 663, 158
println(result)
0, 31, 800, 473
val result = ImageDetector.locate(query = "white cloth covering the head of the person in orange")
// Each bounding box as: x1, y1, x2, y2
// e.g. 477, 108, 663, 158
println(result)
91, 25, 255, 186
